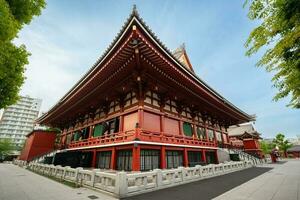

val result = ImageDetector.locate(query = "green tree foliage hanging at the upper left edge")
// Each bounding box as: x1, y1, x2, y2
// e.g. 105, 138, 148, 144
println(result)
0, 0, 46, 108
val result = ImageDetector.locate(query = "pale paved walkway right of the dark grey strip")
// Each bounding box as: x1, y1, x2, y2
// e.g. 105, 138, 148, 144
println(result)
215, 160, 300, 200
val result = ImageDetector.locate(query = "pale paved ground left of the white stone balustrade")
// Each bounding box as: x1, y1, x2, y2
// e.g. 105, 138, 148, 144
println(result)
0, 164, 115, 200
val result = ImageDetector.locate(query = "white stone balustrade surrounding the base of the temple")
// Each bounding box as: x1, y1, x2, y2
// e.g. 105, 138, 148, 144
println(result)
14, 160, 253, 197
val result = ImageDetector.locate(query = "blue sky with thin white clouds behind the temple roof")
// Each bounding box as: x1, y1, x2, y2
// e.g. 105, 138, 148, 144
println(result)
15, 0, 300, 137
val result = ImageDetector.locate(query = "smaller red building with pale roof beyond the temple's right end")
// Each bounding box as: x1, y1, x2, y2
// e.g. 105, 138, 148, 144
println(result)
227, 123, 263, 158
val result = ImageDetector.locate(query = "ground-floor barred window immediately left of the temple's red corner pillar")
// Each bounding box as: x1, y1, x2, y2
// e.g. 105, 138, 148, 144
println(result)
117, 150, 132, 171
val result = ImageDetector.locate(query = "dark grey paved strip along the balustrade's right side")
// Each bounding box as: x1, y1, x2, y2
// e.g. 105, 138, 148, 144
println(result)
123, 167, 273, 200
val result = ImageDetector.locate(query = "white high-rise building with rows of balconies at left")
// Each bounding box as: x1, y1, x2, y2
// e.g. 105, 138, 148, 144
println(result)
0, 96, 42, 146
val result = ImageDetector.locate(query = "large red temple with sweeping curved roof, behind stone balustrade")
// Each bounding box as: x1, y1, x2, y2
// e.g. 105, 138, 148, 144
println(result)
37, 8, 255, 171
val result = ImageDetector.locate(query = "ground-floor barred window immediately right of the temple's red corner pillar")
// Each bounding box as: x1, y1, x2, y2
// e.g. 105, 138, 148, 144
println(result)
140, 149, 160, 171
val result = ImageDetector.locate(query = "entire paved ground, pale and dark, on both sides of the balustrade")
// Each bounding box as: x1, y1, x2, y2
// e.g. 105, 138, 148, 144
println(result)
0, 160, 300, 200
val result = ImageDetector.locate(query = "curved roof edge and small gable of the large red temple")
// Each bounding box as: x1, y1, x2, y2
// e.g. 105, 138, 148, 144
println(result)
37, 6, 255, 124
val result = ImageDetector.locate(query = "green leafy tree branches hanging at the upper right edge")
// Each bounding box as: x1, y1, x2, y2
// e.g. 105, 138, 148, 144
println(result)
245, 0, 300, 108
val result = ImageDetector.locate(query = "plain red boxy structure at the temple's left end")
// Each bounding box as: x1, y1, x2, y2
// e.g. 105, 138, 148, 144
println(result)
20, 130, 57, 161
